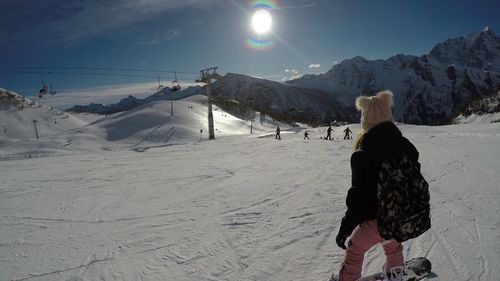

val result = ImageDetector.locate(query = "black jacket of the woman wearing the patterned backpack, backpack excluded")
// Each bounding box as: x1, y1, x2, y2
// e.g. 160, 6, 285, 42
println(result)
339, 122, 418, 236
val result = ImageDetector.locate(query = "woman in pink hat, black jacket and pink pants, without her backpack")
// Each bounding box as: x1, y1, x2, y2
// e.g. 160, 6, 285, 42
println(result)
330, 91, 418, 281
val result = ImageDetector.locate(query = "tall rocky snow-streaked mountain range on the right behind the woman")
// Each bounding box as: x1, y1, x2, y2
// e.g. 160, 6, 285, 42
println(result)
288, 28, 500, 124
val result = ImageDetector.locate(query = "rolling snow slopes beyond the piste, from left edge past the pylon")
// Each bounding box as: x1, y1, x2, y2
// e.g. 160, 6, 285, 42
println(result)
0, 95, 287, 158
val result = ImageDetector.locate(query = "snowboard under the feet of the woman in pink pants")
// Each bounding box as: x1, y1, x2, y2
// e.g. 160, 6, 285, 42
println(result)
330, 257, 432, 281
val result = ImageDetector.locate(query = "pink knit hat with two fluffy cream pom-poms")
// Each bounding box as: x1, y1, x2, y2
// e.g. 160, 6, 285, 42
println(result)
356, 90, 393, 130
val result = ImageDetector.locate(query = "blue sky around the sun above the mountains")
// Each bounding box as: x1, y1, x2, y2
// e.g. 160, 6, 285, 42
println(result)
0, 0, 500, 95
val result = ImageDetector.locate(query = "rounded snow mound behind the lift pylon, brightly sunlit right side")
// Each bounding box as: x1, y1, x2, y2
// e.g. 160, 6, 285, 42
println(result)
83, 95, 284, 148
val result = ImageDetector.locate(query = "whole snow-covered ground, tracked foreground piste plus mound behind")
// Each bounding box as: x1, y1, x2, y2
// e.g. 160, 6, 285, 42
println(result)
0, 97, 500, 281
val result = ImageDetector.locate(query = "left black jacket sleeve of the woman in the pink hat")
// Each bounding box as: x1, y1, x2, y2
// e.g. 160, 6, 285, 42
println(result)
340, 150, 370, 236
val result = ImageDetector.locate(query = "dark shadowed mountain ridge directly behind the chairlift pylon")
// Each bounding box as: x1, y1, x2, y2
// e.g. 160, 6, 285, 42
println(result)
212, 73, 355, 125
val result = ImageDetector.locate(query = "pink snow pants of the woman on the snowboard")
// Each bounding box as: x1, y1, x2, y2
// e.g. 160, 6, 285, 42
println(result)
339, 220, 404, 281
